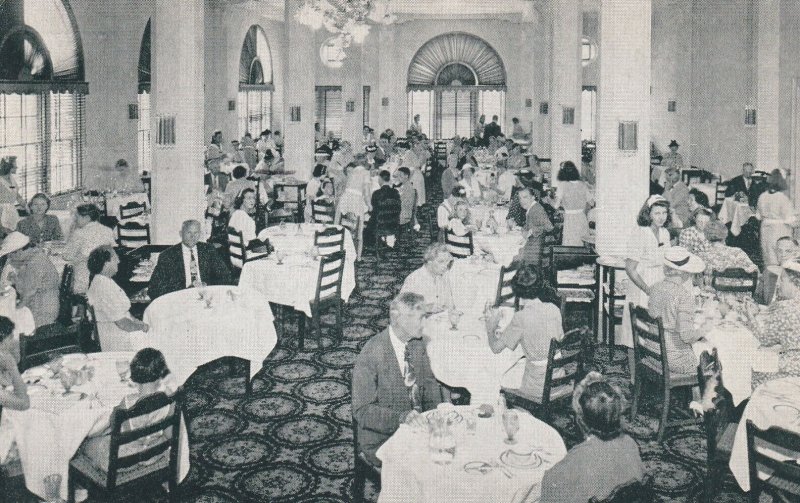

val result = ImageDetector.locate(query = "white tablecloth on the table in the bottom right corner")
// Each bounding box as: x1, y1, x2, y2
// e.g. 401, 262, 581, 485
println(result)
723, 380, 800, 491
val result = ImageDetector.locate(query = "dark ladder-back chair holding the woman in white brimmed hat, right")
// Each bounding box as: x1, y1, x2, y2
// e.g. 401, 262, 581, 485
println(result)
629, 303, 698, 442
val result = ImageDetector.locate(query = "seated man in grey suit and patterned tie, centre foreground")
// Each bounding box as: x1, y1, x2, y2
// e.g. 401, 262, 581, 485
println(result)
352, 292, 443, 466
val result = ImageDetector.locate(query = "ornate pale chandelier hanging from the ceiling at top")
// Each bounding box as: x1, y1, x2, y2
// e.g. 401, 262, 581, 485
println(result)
295, 0, 397, 48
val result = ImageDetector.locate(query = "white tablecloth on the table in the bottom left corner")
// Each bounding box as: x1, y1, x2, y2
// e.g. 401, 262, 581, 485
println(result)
1, 353, 189, 499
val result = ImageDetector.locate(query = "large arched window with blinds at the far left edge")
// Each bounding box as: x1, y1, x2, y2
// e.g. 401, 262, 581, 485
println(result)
0, 0, 89, 198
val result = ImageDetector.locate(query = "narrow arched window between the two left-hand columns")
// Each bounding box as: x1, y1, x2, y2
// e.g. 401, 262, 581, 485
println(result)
238, 25, 275, 138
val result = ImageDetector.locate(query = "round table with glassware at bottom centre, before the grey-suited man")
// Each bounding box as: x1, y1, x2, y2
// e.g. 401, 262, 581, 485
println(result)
376, 404, 567, 503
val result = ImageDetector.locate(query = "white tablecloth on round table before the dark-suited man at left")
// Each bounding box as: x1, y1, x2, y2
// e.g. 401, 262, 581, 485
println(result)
143, 286, 278, 385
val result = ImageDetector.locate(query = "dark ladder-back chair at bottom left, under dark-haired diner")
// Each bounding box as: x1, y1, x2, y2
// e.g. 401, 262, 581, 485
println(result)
68, 393, 181, 503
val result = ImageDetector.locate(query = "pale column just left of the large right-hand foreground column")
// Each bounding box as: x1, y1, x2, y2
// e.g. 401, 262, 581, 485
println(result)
550, 0, 583, 180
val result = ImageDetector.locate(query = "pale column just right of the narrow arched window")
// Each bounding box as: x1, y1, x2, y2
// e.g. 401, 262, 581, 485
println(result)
283, 0, 319, 180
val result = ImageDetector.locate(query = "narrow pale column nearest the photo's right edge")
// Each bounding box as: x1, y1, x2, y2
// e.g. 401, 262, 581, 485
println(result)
756, 0, 789, 172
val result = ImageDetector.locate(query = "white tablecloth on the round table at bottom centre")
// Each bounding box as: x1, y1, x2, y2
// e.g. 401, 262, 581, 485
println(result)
376, 407, 567, 503
